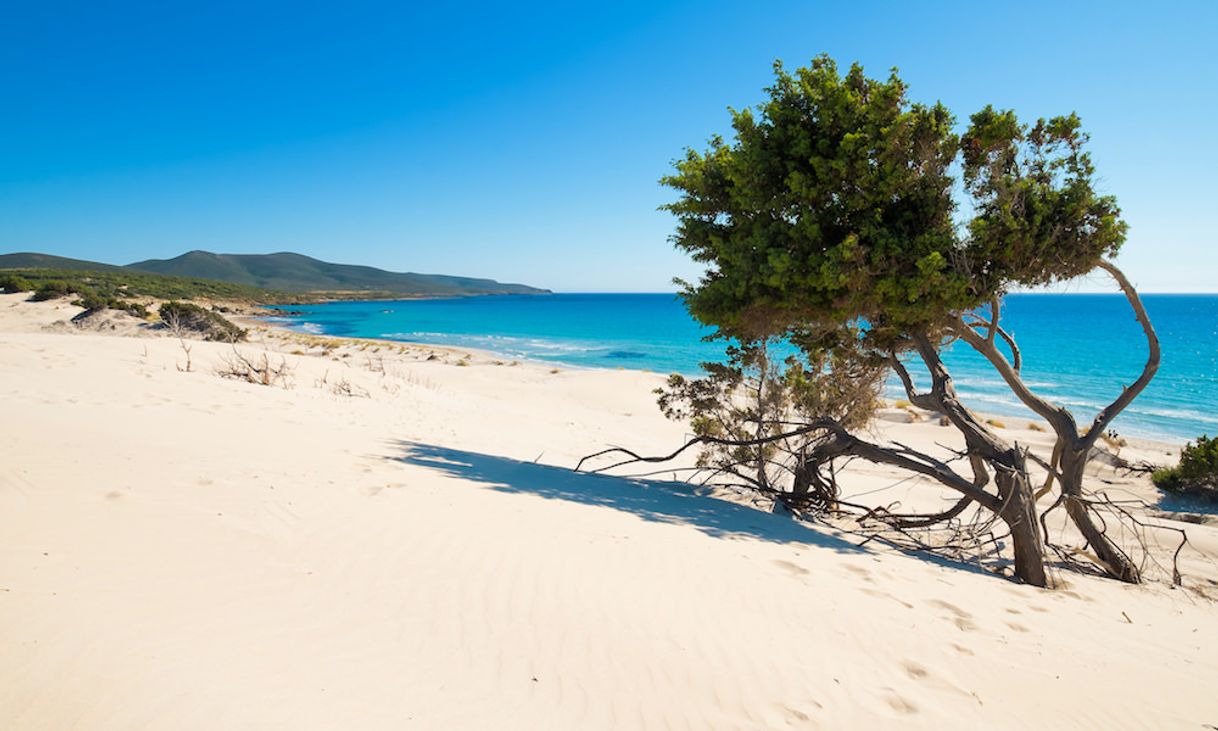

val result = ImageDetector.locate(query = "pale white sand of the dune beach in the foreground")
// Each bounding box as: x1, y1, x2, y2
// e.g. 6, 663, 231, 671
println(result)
0, 296, 1218, 731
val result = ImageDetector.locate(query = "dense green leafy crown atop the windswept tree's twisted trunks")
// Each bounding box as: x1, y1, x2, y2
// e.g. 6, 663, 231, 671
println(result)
663, 56, 1125, 350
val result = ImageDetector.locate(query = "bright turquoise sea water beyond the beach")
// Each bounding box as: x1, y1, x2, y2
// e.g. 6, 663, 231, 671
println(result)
270, 294, 1218, 441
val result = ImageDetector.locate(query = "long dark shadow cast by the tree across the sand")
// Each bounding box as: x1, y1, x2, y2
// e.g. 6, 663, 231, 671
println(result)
390, 441, 988, 574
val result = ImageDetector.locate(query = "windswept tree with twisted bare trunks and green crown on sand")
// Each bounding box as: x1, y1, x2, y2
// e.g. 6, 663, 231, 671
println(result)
584, 56, 1158, 586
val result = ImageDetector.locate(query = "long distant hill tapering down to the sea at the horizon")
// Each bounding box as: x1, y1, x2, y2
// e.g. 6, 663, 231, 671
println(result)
127, 251, 548, 296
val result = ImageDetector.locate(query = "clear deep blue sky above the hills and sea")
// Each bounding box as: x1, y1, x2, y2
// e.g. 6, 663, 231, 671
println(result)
0, 0, 1218, 291
